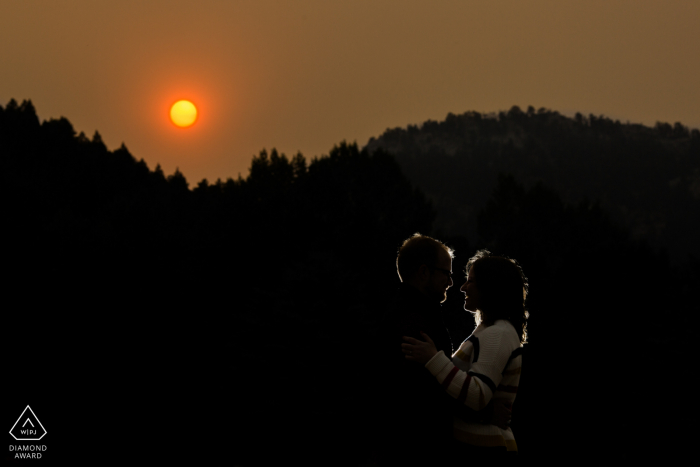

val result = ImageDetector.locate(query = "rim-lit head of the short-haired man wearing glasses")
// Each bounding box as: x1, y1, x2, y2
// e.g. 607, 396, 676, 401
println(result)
396, 233, 454, 302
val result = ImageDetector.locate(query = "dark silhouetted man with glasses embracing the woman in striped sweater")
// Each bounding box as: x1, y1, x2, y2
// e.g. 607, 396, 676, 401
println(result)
377, 234, 503, 467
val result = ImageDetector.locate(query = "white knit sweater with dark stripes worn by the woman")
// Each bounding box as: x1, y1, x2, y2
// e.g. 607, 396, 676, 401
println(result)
425, 320, 522, 451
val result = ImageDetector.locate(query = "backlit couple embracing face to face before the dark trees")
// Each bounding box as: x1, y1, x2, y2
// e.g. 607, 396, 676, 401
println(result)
376, 234, 528, 467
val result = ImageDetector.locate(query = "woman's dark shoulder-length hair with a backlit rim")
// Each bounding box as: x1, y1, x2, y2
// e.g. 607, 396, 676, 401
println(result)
466, 250, 530, 345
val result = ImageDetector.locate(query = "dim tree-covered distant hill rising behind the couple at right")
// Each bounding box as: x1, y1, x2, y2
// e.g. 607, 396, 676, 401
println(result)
366, 107, 700, 261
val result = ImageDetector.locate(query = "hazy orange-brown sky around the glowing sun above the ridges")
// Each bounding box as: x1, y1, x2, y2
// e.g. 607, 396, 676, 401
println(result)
0, 0, 700, 187
